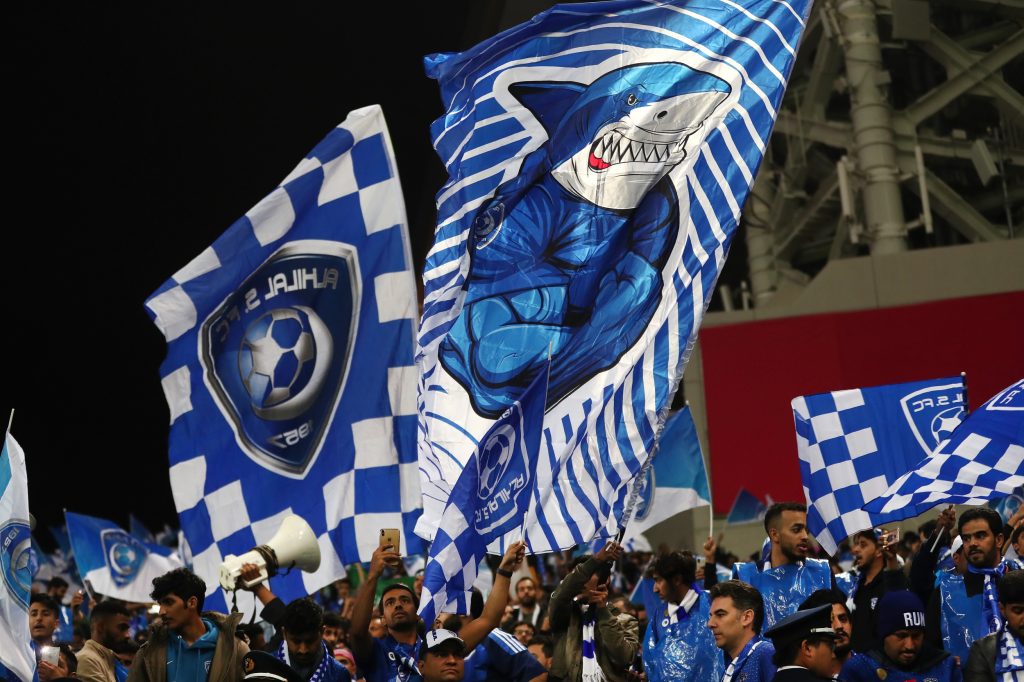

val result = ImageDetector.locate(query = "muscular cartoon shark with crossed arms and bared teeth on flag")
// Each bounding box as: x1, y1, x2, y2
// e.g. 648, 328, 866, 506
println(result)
439, 62, 730, 417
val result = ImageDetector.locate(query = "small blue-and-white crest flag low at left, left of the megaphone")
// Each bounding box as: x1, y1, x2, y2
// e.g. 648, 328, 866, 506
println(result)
65, 512, 182, 602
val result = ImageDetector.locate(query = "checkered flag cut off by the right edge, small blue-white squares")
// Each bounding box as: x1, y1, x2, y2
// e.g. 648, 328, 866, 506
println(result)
866, 379, 1024, 519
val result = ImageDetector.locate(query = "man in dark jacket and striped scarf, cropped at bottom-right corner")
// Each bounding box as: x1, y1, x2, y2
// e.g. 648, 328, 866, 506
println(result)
964, 571, 1024, 682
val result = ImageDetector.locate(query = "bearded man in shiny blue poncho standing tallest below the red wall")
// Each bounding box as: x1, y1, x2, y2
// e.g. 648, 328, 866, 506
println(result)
732, 502, 834, 628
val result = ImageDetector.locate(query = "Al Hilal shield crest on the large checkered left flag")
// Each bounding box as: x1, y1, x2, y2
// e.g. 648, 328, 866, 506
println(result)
201, 240, 360, 478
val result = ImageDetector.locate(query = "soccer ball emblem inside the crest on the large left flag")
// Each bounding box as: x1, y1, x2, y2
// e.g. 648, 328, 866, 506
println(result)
239, 306, 331, 419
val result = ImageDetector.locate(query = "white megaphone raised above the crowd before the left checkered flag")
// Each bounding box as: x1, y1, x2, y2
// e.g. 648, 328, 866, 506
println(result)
220, 514, 319, 590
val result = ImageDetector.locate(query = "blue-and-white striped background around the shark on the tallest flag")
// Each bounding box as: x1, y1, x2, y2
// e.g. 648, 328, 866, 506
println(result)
417, 0, 810, 552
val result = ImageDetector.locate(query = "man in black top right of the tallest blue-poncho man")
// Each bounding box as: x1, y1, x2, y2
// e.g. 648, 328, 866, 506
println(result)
850, 528, 909, 651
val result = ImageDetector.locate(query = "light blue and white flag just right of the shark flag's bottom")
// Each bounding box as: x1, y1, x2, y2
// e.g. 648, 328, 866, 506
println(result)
624, 407, 711, 538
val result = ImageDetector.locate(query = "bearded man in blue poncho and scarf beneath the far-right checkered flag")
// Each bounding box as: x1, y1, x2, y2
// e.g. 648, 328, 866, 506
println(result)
925, 507, 1020, 660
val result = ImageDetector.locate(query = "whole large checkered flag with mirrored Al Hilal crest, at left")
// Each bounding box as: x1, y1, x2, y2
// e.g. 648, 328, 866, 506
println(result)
146, 105, 422, 608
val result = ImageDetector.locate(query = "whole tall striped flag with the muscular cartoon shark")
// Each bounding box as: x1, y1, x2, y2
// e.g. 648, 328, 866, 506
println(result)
417, 0, 810, 552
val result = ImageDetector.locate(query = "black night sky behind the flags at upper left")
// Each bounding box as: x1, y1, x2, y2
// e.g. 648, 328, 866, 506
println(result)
6, 1, 494, 544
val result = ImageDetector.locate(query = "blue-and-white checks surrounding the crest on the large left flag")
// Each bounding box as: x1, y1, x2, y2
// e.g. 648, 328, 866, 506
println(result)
146, 105, 422, 608
